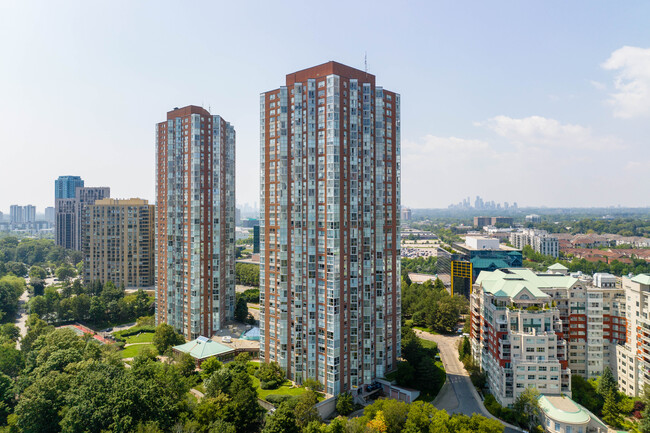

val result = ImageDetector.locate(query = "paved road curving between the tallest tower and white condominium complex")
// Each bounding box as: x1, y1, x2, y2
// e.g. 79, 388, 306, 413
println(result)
415, 330, 521, 433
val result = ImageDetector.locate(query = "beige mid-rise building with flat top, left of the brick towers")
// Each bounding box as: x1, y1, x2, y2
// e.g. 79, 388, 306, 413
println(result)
83, 198, 155, 288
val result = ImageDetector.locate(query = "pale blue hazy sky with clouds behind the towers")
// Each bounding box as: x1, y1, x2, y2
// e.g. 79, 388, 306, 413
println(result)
0, 0, 650, 213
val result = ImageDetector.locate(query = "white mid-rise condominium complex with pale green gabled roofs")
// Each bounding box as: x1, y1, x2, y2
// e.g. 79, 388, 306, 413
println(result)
470, 264, 626, 405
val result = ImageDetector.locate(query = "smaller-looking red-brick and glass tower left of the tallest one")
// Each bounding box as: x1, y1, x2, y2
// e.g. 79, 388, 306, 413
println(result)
156, 105, 235, 339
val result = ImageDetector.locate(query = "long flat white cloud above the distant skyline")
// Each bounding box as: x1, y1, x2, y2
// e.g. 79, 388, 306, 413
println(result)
475, 116, 621, 150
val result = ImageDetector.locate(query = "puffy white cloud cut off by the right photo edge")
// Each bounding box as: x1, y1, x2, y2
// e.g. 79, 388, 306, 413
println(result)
602, 46, 650, 119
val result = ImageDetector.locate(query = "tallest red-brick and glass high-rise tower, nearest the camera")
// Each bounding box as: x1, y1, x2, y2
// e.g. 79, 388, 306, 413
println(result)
260, 62, 401, 395
